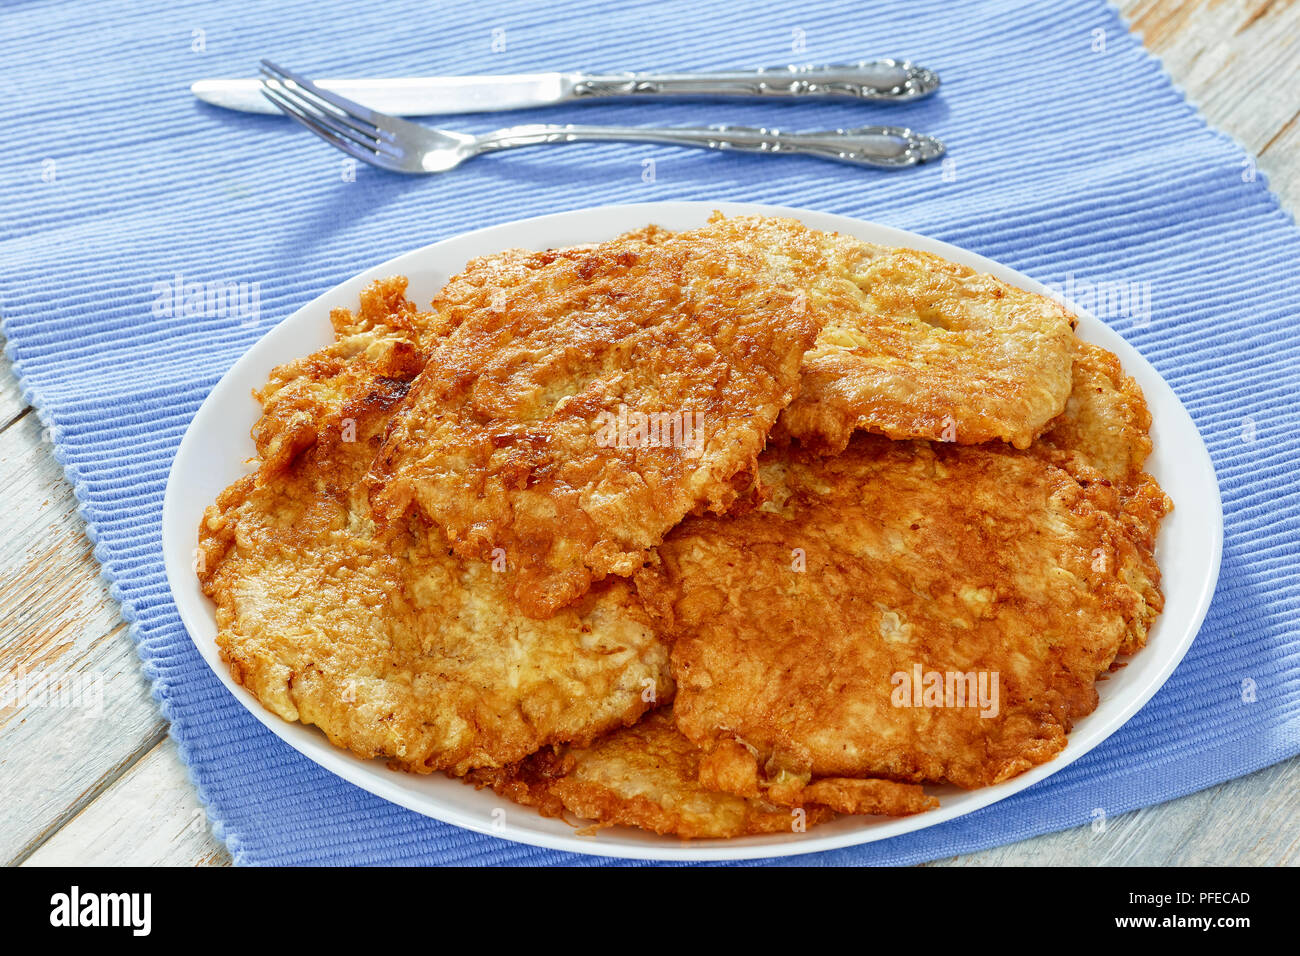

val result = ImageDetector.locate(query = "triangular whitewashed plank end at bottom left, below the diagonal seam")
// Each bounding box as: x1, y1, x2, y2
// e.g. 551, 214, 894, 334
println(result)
23, 737, 230, 866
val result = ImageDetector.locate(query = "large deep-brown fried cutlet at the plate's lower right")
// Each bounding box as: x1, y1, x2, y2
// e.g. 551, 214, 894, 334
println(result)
660, 434, 1161, 799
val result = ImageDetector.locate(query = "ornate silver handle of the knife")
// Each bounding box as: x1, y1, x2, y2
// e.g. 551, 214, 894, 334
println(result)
572, 60, 939, 103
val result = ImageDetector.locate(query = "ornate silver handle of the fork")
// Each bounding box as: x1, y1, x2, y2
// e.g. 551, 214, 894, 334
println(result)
473, 124, 944, 169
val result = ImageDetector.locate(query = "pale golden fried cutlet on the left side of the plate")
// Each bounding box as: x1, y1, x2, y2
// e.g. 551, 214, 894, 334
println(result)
199, 280, 672, 774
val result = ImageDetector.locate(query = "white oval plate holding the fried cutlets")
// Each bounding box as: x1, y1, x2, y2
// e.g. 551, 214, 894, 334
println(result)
163, 202, 1223, 860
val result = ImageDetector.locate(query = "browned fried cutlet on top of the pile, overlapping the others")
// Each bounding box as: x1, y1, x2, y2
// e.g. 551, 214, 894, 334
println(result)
369, 219, 816, 618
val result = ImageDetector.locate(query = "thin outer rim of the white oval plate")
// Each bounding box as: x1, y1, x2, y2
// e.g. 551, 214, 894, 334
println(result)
161, 200, 1223, 862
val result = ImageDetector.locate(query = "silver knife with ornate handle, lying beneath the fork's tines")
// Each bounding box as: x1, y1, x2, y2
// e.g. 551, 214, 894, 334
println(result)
190, 60, 939, 116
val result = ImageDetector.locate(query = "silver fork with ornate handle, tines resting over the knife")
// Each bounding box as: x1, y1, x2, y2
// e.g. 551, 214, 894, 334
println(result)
261, 60, 944, 173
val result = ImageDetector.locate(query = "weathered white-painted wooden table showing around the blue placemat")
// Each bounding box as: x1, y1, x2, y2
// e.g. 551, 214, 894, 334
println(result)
0, 0, 1300, 866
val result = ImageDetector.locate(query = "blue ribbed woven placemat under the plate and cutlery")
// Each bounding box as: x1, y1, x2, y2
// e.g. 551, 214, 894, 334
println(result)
0, 0, 1300, 865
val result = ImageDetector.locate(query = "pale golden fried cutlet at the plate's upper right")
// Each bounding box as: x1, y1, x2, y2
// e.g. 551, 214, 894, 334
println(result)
715, 216, 1074, 454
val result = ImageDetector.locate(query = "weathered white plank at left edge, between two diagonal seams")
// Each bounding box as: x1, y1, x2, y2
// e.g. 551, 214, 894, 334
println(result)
0, 400, 165, 862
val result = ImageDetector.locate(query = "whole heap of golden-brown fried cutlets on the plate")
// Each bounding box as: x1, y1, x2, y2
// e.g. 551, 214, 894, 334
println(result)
200, 216, 1170, 838
